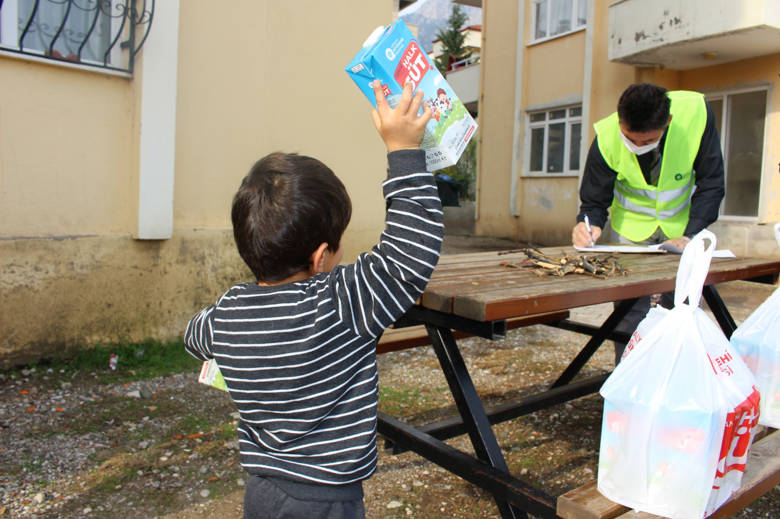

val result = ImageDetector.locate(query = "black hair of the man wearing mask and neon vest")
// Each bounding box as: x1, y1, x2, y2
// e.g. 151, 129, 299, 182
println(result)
618, 83, 671, 133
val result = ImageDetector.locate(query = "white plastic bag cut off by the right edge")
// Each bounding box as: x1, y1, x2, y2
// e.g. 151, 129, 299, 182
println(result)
731, 223, 780, 428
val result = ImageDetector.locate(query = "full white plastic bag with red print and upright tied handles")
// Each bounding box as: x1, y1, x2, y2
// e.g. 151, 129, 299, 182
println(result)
598, 231, 759, 519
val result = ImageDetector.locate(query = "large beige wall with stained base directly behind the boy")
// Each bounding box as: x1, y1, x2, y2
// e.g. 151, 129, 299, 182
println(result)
0, 0, 394, 366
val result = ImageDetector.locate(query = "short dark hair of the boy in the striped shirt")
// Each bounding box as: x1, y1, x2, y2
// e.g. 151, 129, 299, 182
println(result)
231, 153, 352, 283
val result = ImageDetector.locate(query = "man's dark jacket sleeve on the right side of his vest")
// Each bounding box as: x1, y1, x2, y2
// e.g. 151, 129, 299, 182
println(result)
685, 104, 726, 237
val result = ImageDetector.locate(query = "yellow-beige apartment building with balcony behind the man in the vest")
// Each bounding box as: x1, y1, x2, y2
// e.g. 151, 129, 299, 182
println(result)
476, 0, 780, 255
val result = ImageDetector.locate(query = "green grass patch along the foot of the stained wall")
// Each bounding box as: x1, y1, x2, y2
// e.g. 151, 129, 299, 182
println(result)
8, 339, 201, 384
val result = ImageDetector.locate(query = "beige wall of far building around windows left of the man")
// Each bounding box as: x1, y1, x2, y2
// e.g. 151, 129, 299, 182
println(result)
476, 0, 586, 245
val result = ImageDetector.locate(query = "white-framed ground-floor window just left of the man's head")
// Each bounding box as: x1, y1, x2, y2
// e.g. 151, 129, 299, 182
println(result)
528, 106, 582, 175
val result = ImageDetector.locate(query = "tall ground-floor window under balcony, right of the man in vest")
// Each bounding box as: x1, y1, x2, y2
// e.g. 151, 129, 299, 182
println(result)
707, 89, 767, 218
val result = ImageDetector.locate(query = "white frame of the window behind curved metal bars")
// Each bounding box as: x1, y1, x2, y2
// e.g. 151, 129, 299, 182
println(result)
0, 0, 130, 77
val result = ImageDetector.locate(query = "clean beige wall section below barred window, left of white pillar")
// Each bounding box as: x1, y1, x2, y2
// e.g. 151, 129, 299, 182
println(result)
0, 57, 137, 234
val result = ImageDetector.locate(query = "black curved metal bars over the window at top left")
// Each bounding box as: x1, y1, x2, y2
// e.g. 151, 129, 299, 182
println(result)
0, 0, 155, 74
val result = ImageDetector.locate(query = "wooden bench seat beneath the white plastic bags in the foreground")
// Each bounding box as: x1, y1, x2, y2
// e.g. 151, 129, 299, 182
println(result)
556, 429, 780, 519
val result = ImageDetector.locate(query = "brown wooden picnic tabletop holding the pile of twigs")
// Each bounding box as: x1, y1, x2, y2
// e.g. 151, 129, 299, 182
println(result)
421, 247, 780, 321
